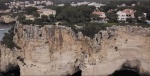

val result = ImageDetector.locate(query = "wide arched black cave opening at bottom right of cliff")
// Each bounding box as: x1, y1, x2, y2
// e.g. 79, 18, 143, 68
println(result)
110, 69, 140, 76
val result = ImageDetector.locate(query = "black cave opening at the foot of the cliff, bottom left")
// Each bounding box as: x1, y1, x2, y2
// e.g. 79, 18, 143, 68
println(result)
2, 66, 20, 76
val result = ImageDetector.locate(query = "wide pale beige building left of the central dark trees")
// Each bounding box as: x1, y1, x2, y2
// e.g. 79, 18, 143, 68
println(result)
38, 9, 56, 17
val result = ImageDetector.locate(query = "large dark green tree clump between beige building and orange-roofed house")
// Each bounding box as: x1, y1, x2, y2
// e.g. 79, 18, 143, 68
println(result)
56, 6, 95, 23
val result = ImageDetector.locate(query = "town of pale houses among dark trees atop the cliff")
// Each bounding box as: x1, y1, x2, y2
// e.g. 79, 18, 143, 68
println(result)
0, 0, 150, 24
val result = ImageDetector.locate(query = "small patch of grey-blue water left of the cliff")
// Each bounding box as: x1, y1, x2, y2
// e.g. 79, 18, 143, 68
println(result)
0, 24, 14, 41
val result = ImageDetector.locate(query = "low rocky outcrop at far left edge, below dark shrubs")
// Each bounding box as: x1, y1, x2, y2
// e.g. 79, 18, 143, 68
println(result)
0, 45, 20, 72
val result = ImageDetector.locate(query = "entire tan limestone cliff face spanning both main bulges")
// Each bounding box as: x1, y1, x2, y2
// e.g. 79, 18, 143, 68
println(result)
1, 25, 150, 76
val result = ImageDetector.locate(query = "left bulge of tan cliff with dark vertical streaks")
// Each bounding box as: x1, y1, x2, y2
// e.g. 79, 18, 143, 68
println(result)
14, 26, 93, 75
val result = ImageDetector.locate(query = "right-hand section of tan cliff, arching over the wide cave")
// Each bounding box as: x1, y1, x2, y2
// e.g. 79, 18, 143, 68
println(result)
82, 26, 150, 75
